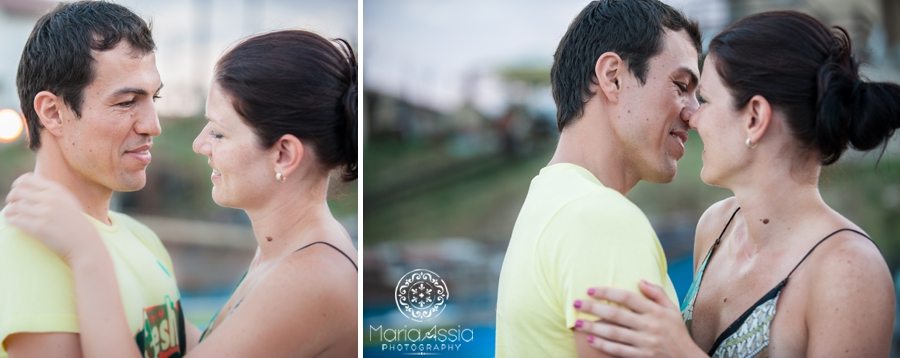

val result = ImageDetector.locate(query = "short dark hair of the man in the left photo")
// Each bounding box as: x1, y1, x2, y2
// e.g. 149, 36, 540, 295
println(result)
16, 1, 156, 150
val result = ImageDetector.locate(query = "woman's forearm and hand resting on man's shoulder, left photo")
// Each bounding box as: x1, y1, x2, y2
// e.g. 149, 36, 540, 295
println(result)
5, 174, 140, 357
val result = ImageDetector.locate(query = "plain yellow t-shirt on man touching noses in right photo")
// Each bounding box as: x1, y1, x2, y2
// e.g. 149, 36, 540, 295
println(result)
496, 163, 678, 357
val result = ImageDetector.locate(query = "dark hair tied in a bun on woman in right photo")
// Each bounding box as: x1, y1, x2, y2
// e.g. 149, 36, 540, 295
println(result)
709, 11, 900, 165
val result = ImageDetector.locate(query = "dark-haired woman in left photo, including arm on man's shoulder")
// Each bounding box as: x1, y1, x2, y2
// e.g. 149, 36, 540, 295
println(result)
9, 30, 358, 357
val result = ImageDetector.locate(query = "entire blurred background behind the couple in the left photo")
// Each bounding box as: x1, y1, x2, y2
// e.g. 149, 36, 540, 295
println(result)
0, 0, 358, 328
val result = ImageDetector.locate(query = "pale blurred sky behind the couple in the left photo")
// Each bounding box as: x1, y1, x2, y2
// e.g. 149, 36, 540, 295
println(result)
0, 0, 358, 116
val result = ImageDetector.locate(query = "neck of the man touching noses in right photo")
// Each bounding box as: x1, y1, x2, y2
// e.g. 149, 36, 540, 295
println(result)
548, 118, 640, 195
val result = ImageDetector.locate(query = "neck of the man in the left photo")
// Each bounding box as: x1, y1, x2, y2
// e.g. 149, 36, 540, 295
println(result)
34, 148, 112, 224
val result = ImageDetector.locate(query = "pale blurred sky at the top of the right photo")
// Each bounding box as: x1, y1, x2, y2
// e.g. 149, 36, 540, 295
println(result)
363, 0, 728, 114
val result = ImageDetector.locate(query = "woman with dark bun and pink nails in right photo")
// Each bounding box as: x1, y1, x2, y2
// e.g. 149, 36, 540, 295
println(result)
575, 11, 900, 357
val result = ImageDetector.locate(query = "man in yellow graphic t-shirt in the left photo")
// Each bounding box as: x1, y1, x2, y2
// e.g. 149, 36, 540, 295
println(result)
0, 1, 190, 358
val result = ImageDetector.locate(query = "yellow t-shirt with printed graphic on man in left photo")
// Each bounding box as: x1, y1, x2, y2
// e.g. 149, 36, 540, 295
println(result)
0, 212, 186, 358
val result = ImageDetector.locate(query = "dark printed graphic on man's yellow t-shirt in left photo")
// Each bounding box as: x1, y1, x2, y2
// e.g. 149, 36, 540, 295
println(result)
134, 296, 186, 358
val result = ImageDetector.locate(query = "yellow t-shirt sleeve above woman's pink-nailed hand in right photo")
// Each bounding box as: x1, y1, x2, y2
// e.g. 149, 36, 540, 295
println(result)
547, 198, 667, 328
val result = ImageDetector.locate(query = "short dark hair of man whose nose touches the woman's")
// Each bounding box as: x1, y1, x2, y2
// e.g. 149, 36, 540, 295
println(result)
550, 0, 701, 131
